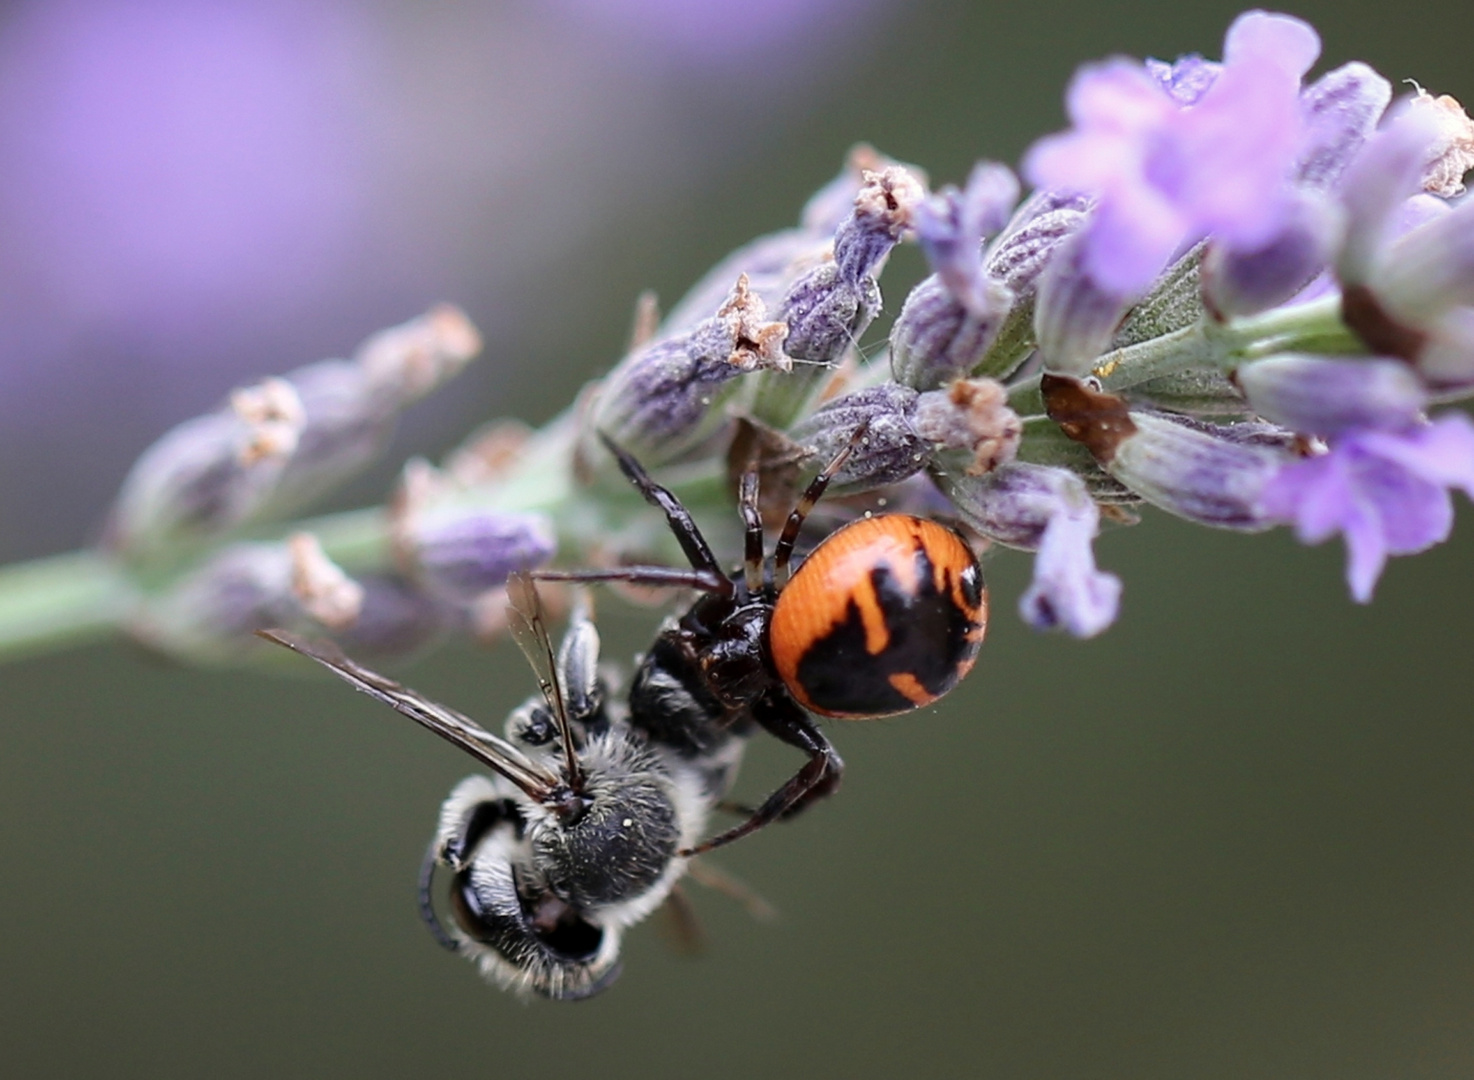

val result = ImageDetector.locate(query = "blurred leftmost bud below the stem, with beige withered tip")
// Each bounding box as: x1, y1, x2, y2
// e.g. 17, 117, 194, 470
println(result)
128, 533, 366, 665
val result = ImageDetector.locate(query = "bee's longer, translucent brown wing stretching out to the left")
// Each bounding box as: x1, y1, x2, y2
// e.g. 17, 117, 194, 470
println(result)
256, 631, 560, 800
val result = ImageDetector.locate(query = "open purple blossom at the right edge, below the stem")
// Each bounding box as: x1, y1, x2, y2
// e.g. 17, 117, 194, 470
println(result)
1260, 413, 1474, 604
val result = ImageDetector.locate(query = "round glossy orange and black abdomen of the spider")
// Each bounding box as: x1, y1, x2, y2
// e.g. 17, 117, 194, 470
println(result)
769, 514, 988, 719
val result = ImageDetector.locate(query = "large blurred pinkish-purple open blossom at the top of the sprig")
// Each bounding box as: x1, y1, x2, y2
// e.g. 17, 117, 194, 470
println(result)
1023, 12, 1321, 295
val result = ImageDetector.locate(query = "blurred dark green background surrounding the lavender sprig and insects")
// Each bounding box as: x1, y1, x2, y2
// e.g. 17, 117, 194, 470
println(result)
0, 0, 1474, 1080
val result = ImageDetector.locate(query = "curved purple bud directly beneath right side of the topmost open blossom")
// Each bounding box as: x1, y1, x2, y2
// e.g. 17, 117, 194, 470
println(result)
1201, 194, 1341, 320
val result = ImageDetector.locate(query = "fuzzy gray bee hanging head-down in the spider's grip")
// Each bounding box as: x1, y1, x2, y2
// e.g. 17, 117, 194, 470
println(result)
262, 578, 746, 1000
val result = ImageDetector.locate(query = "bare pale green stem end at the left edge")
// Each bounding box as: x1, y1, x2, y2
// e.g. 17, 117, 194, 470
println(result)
0, 551, 136, 660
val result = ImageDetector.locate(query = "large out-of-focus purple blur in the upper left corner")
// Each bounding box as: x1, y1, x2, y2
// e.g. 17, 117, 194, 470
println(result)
0, 0, 374, 328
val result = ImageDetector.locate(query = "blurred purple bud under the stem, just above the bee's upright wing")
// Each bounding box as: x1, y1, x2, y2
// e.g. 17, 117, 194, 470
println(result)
391, 461, 557, 604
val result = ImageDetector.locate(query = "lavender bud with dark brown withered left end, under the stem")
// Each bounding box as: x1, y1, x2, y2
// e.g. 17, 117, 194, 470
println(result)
1042, 374, 1290, 532
